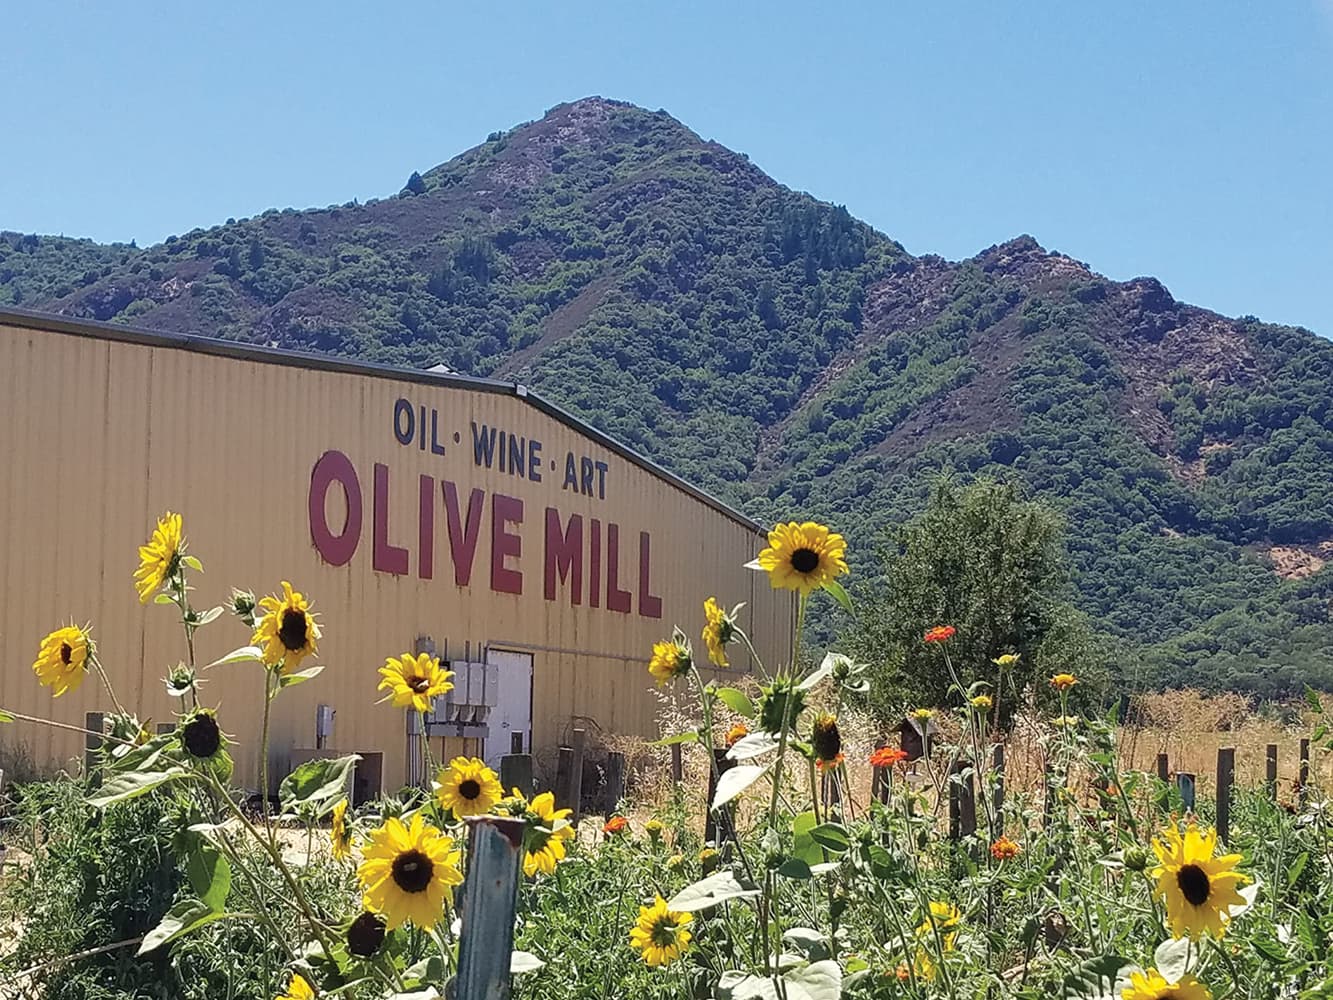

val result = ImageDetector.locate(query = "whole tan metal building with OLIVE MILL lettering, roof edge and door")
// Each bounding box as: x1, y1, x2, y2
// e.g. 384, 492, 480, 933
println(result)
0, 312, 794, 795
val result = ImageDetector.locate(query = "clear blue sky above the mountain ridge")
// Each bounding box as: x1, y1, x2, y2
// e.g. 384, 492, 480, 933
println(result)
0, 0, 1333, 335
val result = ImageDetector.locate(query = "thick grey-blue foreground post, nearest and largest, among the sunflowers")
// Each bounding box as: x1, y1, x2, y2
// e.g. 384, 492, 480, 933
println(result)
455, 816, 527, 1000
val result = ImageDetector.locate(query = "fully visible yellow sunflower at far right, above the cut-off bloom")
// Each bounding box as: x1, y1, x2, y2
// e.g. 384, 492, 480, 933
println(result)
1149, 823, 1249, 941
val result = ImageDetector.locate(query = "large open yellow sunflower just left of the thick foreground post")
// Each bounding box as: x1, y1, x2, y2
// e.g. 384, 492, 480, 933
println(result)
356, 813, 463, 931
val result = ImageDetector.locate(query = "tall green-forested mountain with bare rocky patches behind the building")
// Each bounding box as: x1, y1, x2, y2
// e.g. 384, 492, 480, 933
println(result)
0, 97, 1333, 695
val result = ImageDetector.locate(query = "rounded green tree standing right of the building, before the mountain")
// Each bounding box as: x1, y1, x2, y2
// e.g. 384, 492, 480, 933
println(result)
848, 479, 1105, 724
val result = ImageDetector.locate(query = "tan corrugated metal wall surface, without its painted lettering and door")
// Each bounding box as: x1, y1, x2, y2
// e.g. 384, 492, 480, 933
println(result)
0, 318, 792, 787
